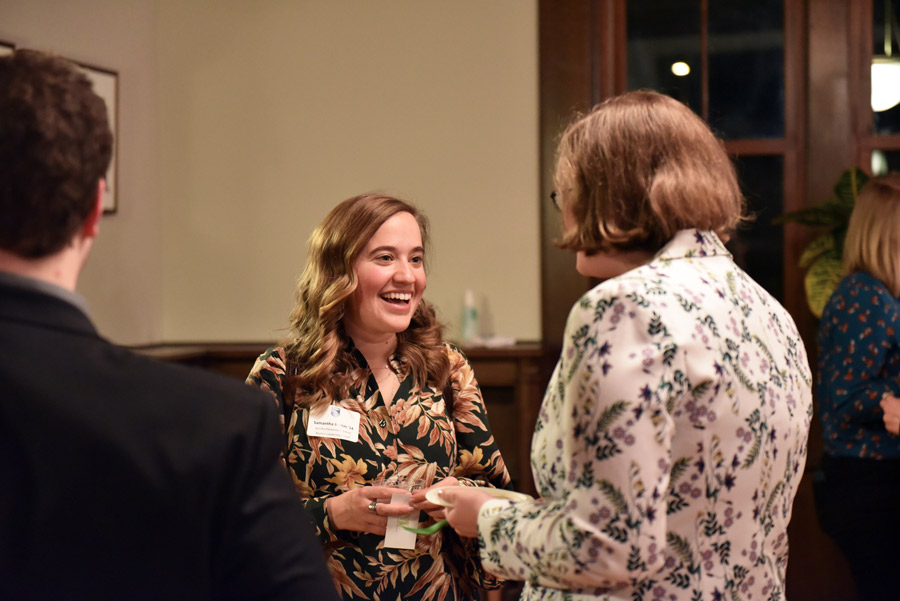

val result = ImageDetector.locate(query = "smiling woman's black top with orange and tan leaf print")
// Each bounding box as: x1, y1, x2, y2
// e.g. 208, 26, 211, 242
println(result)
247, 345, 510, 601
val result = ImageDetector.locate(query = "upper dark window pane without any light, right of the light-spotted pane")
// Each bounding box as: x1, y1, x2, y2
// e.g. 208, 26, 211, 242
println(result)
708, 0, 784, 140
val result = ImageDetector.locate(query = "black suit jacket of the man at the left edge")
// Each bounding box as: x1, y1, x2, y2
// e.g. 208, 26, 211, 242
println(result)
0, 284, 337, 601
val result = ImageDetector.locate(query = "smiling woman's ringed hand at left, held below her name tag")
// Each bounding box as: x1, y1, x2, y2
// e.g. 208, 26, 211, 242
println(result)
325, 486, 413, 535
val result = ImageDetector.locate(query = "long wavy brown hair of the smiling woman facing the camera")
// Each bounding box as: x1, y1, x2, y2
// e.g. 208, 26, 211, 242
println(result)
283, 193, 450, 407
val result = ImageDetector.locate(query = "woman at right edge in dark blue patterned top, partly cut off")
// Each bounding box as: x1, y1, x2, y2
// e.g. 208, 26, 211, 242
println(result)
816, 173, 900, 601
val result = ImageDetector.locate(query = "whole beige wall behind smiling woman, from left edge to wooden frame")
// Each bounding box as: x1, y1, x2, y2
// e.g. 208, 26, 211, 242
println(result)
0, 0, 540, 343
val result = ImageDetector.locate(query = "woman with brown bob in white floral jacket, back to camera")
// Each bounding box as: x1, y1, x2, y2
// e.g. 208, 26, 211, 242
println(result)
442, 91, 812, 601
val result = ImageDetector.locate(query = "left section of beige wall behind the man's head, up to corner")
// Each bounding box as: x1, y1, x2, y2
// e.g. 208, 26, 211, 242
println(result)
0, 0, 163, 344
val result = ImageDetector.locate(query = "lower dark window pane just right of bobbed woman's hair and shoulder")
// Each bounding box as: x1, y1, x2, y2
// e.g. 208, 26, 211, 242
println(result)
728, 156, 784, 300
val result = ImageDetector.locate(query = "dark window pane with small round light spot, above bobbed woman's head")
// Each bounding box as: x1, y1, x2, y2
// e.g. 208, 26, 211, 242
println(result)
627, 0, 703, 115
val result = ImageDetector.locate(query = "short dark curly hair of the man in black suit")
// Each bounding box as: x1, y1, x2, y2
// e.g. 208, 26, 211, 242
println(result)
0, 50, 113, 259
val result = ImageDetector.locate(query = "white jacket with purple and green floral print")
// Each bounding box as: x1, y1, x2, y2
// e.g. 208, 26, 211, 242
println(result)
479, 230, 812, 601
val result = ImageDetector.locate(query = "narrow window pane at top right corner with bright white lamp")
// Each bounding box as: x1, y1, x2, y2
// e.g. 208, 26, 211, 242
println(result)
872, 0, 900, 134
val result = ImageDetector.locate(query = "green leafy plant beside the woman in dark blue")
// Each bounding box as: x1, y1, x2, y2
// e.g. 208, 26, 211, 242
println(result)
773, 167, 869, 318
